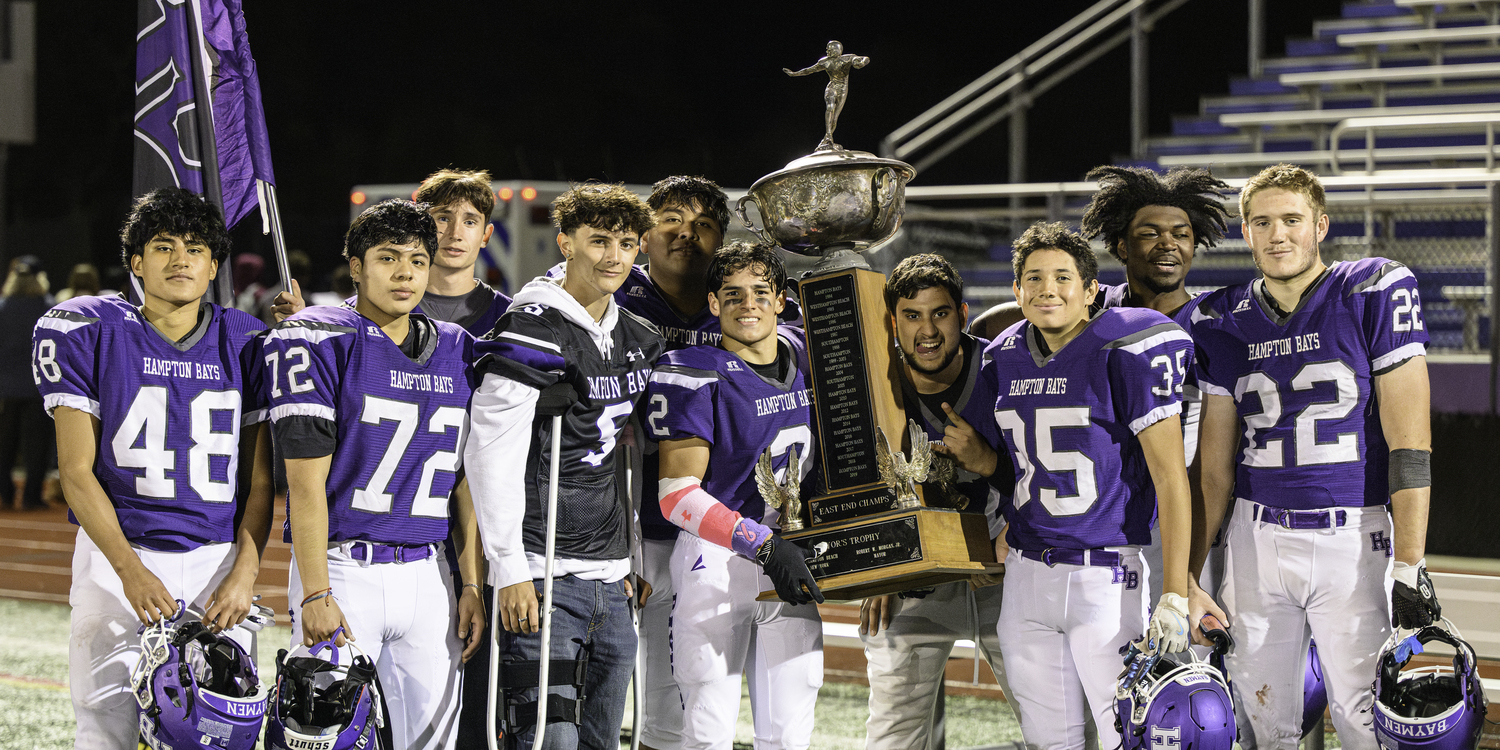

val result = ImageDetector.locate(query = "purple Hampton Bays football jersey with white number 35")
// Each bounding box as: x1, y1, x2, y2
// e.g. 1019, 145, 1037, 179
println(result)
984, 308, 1193, 549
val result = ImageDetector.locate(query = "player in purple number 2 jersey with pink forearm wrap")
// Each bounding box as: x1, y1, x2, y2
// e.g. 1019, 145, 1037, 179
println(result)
647, 242, 824, 750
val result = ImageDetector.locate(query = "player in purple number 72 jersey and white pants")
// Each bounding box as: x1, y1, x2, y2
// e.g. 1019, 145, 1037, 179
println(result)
264, 200, 485, 749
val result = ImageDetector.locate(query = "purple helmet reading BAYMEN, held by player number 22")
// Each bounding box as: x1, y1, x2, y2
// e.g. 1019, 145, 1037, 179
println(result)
1374, 620, 1490, 750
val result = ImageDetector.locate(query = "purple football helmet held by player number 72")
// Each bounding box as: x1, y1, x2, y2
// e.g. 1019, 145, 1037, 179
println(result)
266, 629, 392, 750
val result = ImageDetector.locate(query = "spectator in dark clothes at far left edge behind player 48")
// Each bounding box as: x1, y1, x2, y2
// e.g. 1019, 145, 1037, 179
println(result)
0, 255, 54, 510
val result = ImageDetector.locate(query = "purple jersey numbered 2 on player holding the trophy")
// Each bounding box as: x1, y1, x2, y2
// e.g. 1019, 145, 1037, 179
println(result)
645, 326, 815, 525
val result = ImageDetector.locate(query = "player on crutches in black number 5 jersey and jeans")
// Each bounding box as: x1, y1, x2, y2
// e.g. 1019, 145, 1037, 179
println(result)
467, 185, 662, 749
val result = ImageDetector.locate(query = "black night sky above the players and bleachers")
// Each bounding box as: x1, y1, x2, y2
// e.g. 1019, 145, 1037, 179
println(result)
6, 0, 1338, 287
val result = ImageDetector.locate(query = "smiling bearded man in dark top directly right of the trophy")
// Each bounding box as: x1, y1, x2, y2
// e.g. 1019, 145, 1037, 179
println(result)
860, 255, 1014, 750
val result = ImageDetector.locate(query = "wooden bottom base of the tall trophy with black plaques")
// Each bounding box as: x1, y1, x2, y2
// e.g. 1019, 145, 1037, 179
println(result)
758, 509, 1004, 602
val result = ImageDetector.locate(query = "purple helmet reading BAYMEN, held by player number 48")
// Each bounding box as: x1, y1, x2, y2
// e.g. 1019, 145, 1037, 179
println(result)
131, 600, 266, 750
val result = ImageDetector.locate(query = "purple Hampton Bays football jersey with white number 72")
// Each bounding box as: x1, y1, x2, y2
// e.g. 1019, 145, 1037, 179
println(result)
264, 306, 474, 545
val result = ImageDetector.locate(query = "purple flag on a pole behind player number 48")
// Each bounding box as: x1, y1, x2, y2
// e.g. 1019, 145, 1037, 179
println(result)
134, 0, 275, 241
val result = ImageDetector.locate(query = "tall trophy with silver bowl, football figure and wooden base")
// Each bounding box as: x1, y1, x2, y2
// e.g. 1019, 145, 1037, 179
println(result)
735, 42, 1001, 600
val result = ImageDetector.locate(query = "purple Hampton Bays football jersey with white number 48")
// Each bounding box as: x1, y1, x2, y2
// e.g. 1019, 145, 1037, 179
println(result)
32, 297, 266, 552
